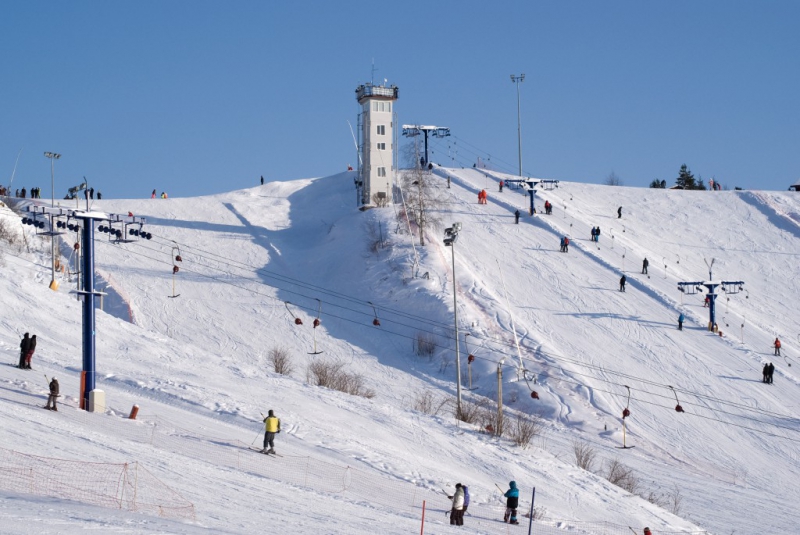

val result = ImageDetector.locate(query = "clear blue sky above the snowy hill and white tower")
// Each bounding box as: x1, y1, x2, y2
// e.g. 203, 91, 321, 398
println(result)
0, 0, 800, 197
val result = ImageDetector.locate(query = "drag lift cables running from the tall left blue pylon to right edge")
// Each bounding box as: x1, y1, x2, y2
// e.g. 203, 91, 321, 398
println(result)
99, 241, 792, 428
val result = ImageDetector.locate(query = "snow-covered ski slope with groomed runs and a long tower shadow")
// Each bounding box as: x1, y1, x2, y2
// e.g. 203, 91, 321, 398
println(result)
0, 173, 800, 534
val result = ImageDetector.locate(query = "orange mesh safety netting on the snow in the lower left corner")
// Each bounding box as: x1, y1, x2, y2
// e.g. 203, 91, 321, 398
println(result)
0, 449, 195, 520
